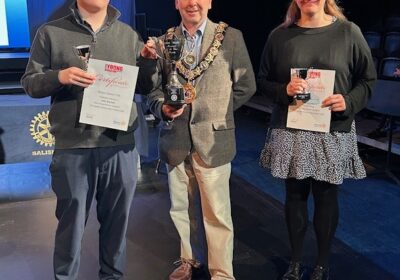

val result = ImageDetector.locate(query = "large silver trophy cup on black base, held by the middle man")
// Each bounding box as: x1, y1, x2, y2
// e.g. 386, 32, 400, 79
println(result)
150, 34, 186, 107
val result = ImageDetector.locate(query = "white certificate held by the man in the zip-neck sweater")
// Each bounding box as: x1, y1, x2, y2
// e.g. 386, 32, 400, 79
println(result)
79, 59, 139, 131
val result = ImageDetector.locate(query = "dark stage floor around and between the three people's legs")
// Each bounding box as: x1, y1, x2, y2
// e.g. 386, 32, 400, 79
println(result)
0, 164, 395, 280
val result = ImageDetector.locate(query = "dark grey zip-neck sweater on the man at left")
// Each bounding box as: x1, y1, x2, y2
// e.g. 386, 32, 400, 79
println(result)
21, 4, 157, 149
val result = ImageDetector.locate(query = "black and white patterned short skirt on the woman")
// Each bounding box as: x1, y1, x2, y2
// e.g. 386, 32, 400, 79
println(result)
260, 122, 366, 184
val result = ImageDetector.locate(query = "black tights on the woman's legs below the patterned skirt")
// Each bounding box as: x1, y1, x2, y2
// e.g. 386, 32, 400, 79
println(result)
285, 178, 339, 267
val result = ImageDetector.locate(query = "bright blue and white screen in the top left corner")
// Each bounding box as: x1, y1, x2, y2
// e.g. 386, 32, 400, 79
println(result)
0, 0, 30, 49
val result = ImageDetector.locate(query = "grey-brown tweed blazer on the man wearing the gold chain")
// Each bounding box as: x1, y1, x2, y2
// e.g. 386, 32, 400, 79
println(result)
148, 20, 256, 167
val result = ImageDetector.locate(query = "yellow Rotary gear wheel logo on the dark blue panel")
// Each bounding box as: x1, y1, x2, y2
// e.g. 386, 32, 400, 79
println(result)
29, 111, 54, 147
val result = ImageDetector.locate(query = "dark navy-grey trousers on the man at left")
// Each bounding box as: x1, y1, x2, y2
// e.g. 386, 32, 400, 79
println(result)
50, 145, 138, 280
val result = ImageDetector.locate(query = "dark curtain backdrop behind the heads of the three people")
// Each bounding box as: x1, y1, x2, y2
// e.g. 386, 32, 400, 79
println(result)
17, 0, 400, 72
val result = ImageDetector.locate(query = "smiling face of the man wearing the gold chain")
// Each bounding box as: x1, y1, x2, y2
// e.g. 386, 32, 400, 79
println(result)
175, 0, 212, 28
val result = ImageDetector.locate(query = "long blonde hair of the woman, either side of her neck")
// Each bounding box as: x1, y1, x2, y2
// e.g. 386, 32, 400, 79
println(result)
281, 0, 346, 27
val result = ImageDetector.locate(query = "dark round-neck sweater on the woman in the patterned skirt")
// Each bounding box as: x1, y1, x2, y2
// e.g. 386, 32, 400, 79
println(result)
257, 20, 376, 132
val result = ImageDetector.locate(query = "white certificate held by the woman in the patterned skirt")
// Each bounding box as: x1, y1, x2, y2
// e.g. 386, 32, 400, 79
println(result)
286, 68, 335, 132
